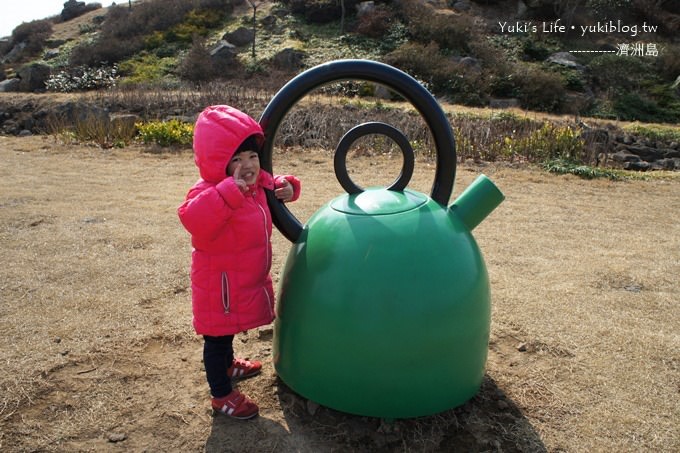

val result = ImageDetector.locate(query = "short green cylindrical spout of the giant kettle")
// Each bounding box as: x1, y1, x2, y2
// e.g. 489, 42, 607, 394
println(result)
449, 175, 505, 231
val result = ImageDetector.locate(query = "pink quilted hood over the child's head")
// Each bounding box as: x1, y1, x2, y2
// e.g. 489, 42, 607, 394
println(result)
194, 105, 264, 184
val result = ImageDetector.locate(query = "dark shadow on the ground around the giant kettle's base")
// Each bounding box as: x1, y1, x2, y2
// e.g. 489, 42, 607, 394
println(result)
205, 375, 547, 453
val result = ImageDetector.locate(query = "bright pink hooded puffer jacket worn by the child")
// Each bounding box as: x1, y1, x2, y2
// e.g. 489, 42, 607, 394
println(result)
178, 105, 300, 336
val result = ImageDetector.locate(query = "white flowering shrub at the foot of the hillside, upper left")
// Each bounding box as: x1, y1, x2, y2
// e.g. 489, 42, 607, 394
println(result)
45, 65, 119, 93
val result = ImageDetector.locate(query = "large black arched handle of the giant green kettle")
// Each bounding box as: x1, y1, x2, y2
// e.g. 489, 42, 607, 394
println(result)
259, 60, 456, 242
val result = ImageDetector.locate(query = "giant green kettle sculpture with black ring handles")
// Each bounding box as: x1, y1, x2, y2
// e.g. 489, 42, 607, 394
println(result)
260, 60, 503, 418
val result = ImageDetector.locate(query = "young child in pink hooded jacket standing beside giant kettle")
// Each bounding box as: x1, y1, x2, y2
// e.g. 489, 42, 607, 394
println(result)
178, 105, 300, 419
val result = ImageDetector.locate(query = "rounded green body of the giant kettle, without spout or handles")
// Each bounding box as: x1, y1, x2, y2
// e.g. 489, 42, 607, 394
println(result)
274, 189, 491, 418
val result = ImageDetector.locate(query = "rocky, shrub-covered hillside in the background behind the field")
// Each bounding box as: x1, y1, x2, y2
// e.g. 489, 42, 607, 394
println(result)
0, 0, 680, 123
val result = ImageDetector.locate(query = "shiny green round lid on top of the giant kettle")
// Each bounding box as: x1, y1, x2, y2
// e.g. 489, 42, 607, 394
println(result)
330, 187, 428, 215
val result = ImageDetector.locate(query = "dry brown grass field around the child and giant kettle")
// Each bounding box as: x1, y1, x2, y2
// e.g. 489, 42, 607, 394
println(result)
0, 137, 680, 452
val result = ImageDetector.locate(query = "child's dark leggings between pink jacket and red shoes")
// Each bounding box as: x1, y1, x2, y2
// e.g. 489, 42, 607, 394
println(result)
203, 335, 234, 398
